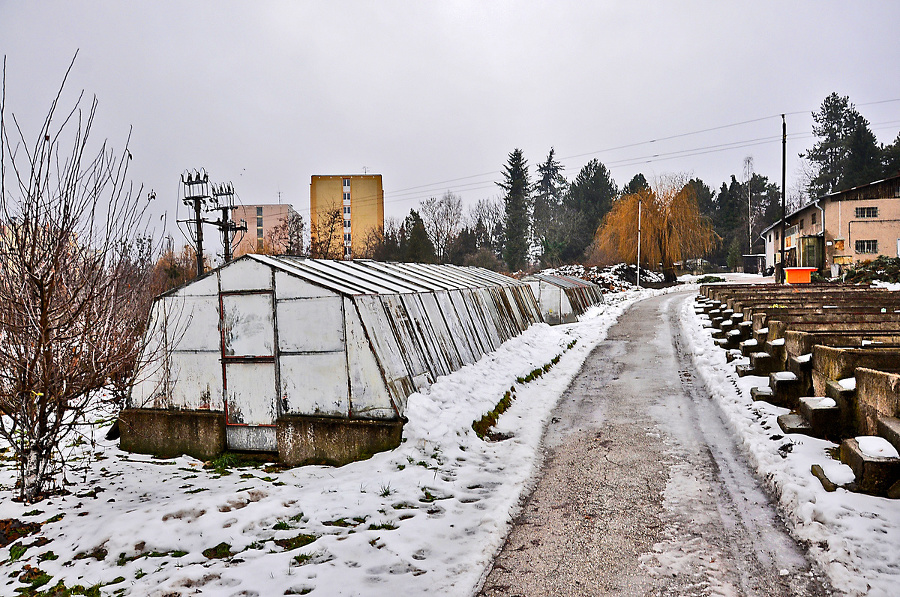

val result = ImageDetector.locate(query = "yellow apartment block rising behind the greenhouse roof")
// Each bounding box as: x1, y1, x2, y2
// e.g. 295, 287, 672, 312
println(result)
309, 174, 384, 259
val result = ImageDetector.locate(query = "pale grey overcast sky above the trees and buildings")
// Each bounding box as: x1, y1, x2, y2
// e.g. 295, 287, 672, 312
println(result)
0, 0, 900, 254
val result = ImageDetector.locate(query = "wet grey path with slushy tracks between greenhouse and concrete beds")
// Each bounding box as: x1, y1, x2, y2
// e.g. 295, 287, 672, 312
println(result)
481, 293, 827, 596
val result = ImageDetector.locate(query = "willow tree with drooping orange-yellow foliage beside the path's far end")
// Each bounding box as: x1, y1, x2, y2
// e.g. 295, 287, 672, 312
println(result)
592, 177, 721, 281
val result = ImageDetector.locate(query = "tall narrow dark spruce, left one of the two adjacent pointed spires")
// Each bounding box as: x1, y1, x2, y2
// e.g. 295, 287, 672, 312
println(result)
497, 148, 531, 271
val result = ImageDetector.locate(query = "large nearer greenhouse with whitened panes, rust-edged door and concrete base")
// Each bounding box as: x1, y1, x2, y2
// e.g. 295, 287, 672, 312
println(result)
120, 255, 541, 464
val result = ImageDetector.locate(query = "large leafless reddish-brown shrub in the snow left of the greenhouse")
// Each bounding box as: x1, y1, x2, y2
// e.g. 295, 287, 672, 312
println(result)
0, 59, 152, 501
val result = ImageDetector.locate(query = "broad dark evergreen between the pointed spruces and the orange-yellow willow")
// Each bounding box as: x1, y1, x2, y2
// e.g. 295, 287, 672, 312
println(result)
563, 158, 618, 260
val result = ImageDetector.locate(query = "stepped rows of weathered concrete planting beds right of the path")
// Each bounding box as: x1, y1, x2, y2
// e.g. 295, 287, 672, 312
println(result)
698, 285, 900, 497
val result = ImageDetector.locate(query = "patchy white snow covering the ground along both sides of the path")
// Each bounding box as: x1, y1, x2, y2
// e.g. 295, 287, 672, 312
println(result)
0, 277, 900, 596
